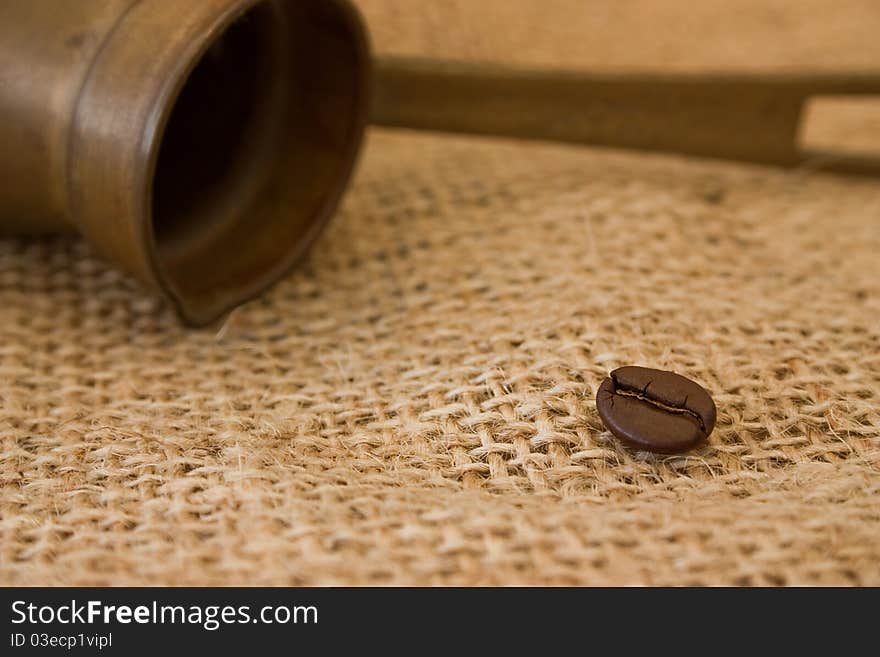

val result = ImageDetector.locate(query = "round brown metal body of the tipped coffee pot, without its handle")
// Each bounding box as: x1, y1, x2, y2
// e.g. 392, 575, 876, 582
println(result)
0, 0, 370, 325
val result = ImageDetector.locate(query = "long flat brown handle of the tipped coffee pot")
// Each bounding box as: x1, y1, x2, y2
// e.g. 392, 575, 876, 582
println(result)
372, 57, 880, 173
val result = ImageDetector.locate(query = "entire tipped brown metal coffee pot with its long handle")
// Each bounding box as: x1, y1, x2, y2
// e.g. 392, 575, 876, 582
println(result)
0, 0, 880, 325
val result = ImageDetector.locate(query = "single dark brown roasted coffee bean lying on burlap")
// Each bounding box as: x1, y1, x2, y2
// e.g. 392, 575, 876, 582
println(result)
596, 365, 715, 454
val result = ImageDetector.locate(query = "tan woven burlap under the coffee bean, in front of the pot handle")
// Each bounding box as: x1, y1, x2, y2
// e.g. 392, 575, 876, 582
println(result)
0, 2, 880, 584
